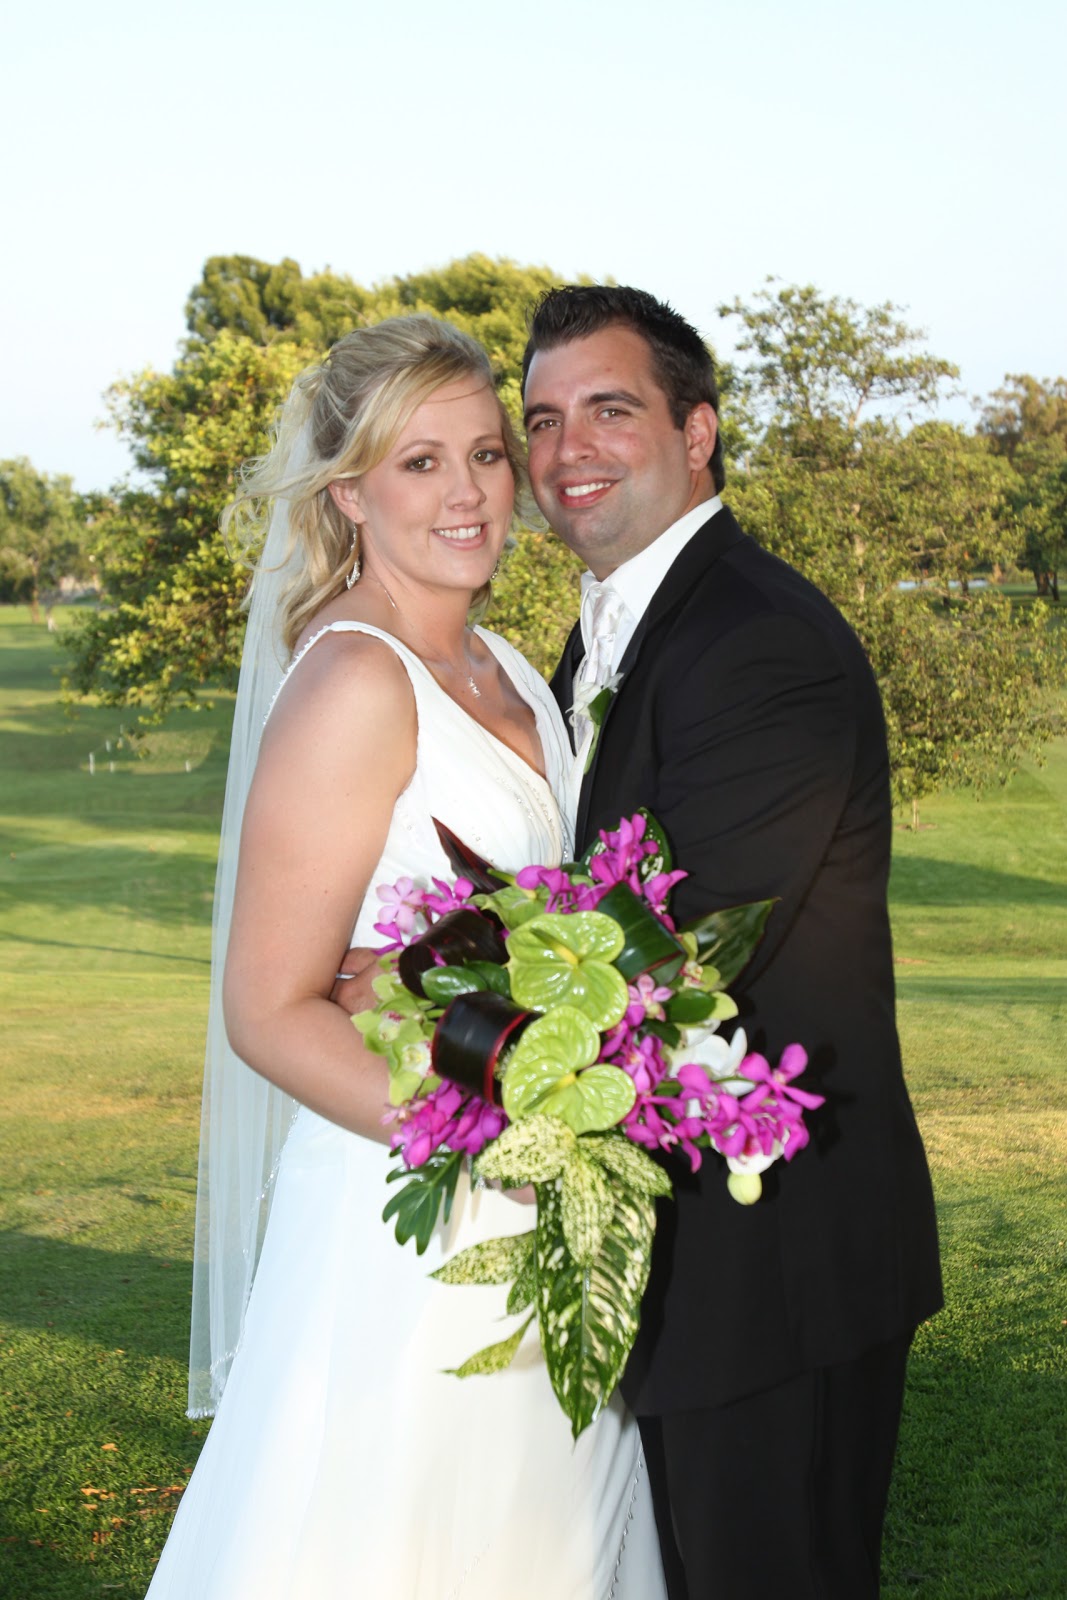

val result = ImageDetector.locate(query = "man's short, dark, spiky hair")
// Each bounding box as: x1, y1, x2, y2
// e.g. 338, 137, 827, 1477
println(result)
523, 283, 726, 491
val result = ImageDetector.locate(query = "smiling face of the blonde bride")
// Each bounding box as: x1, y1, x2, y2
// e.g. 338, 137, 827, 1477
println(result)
330, 378, 515, 592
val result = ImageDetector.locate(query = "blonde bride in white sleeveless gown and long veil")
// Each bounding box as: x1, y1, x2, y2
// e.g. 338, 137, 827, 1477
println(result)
149, 317, 664, 1600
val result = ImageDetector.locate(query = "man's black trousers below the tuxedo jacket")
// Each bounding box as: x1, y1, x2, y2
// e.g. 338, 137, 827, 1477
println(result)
638, 1334, 912, 1600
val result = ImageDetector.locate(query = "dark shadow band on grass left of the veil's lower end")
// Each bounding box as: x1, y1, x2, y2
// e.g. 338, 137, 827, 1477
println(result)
0, 1230, 192, 1363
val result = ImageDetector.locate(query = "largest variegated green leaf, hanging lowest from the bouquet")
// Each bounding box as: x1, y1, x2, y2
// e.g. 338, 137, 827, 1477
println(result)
537, 1179, 656, 1438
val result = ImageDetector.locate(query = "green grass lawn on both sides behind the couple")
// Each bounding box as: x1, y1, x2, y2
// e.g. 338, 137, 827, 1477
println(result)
0, 610, 1067, 1600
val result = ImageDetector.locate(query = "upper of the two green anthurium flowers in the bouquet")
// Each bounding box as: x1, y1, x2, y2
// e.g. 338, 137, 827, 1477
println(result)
507, 910, 629, 1030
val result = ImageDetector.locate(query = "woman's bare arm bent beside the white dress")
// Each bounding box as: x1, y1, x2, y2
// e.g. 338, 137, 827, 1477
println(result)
224, 634, 418, 1141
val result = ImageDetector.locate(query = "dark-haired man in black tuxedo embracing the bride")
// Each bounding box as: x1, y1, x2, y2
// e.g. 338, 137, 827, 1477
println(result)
523, 288, 941, 1600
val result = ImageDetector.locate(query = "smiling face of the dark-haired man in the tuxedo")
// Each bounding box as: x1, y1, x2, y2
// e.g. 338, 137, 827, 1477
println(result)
525, 326, 715, 578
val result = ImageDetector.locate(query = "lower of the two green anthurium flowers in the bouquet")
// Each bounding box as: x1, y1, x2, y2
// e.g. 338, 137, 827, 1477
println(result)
504, 1005, 637, 1133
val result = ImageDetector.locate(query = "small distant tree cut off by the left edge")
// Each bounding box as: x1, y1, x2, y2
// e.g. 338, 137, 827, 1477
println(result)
0, 456, 91, 622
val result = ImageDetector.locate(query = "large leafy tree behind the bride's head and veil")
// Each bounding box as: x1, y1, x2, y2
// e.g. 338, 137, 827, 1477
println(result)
69, 256, 585, 720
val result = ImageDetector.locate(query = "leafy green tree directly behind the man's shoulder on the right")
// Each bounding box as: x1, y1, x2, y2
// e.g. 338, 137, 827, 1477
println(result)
723, 288, 1064, 822
